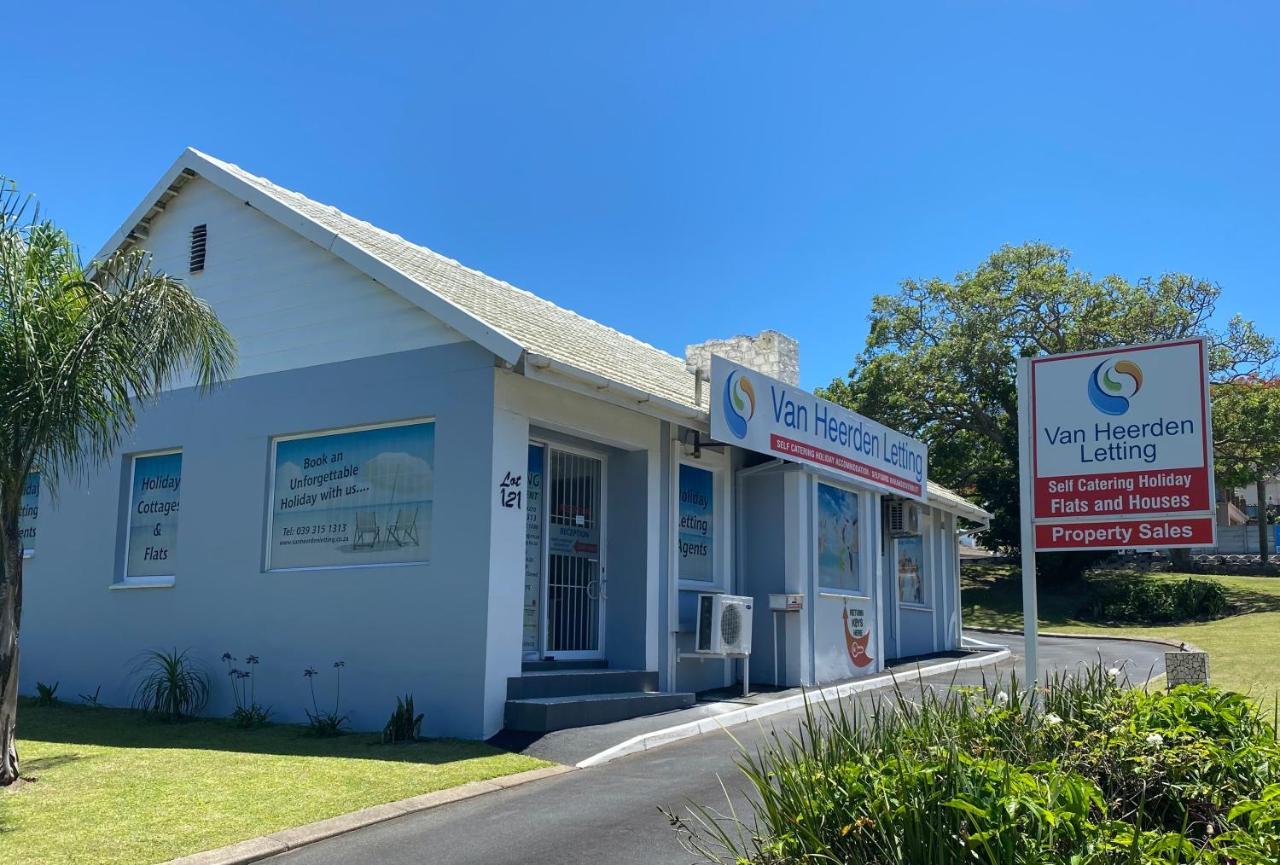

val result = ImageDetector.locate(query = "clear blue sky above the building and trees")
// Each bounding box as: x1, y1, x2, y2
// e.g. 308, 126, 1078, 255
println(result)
0, 0, 1280, 386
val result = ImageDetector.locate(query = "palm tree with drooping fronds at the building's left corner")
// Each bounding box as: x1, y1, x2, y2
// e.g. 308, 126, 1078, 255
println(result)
0, 178, 236, 787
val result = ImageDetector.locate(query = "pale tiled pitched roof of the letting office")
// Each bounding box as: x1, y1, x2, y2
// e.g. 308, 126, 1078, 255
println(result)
102, 147, 989, 522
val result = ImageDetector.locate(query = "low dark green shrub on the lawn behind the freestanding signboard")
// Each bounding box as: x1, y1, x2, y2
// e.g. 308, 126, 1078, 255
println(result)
1076, 577, 1230, 624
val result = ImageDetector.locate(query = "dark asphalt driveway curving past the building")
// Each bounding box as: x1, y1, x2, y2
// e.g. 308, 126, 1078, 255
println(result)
270, 635, 1164, 865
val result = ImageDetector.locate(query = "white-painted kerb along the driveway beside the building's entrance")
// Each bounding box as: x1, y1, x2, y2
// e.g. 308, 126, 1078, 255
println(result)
577, 647, 1012, 769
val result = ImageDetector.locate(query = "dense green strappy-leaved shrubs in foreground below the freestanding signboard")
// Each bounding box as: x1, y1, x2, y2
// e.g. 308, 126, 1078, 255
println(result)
668, 668, 1280, 865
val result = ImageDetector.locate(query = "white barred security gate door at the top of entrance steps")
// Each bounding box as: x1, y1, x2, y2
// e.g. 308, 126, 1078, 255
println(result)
544, 449, 605, 659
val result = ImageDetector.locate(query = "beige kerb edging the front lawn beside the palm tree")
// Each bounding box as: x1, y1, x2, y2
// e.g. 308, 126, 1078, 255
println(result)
163, 765, 573, 865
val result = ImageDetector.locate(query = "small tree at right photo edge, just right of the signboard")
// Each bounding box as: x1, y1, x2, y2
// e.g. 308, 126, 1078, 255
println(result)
1213, 375, 1280, 563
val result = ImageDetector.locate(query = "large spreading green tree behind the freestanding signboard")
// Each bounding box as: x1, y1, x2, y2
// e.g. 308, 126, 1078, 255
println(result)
823, 243, 1276, 562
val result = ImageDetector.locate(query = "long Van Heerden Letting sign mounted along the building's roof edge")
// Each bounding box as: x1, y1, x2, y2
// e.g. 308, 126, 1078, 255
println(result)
712, 354, 929, 502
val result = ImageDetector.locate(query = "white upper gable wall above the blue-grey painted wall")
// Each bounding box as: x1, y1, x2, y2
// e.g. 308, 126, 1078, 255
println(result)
142, 178, 465, 376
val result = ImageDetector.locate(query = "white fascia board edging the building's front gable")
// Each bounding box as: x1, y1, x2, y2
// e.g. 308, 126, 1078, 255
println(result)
99, 147, 524, 363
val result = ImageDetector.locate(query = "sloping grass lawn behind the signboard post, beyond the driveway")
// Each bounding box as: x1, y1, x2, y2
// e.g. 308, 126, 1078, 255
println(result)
961, 563, 1280, 706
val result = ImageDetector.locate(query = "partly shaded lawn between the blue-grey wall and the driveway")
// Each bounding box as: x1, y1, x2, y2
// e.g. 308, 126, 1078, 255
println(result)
0, 700, 548, 865
